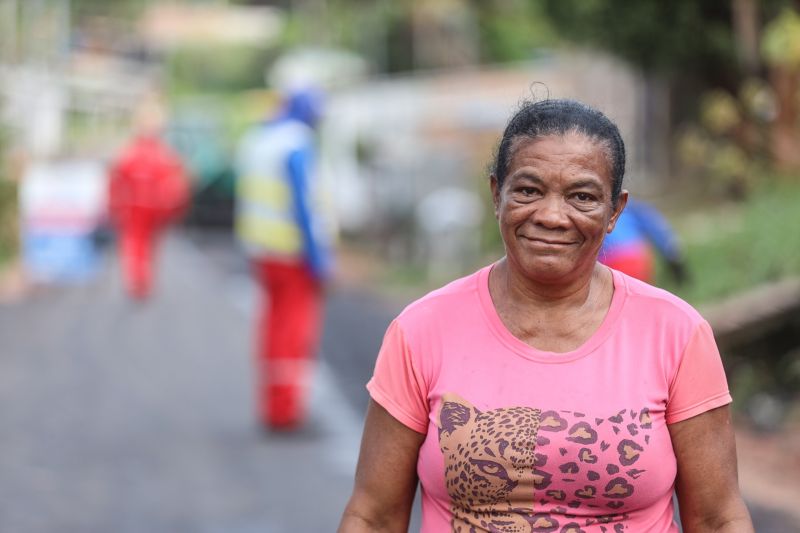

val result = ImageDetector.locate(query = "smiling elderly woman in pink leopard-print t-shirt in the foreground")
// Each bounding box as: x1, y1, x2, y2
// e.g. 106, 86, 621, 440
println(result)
340, 100, 753, 533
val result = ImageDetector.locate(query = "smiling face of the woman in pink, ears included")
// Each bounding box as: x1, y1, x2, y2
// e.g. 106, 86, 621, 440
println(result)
491, 133, 628, 283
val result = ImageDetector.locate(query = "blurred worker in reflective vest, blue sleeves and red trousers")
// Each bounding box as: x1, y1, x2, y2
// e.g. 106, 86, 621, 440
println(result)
236, 89, 334, 429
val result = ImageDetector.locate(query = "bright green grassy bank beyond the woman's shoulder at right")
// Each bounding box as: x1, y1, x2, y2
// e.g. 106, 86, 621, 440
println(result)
657, 178, 800, 305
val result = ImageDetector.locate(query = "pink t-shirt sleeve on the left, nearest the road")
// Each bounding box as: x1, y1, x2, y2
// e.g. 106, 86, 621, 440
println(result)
367, 320, 428, 434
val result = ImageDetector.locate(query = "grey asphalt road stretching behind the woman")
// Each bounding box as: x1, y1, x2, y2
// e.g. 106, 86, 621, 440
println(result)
0, 233, 792, 533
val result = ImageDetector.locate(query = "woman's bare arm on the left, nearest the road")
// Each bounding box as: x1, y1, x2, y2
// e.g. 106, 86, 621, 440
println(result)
339, 400, 425, 533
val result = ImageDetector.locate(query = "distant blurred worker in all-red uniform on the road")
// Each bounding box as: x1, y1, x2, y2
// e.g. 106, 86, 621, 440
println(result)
109, 93, 189, 299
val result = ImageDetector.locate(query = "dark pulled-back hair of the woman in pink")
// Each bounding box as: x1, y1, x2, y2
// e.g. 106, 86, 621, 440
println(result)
492, 99, 625, 205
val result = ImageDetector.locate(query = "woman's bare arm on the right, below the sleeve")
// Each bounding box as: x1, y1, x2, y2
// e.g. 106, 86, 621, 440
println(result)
669, 405, 754, 533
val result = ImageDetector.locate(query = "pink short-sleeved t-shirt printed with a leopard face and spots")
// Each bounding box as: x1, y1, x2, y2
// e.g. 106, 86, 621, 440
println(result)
367, 267, 731, 533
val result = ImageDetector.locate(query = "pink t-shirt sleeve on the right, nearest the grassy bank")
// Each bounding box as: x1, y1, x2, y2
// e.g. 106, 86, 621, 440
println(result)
666, 320, 732, 424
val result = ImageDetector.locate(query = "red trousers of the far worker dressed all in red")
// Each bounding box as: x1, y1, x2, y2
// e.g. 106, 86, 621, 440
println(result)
119, 223, 158, 299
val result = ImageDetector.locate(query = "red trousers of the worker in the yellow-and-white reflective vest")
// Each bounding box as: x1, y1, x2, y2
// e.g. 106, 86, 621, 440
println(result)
253, 260, 323, 428
